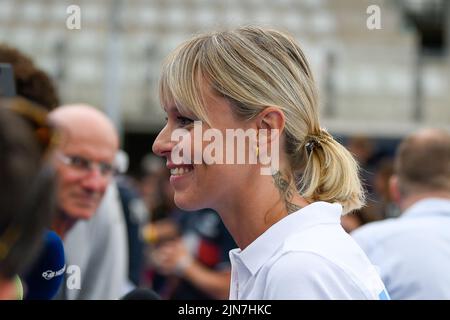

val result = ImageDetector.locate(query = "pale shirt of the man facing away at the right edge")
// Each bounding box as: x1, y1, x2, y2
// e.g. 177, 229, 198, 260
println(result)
352, 198, 450, 300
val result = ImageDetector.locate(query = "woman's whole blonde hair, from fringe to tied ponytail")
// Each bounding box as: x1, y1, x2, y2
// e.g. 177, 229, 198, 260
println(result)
159, 26, 364, 213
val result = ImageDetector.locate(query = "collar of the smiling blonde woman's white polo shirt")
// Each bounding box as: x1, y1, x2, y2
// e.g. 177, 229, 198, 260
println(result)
230, 201, 342, 275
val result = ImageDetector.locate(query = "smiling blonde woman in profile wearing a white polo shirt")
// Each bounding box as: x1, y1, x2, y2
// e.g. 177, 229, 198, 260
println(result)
153, 27, 388, 299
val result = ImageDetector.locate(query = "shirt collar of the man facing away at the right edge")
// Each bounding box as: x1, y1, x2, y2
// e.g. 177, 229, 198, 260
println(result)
400, 198, 450, 218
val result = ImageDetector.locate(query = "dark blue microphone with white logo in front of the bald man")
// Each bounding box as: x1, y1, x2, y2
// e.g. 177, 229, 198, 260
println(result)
24, 231, 66, 300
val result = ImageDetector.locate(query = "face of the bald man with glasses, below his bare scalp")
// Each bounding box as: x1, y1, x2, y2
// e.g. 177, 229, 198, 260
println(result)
55, 132, 117, 220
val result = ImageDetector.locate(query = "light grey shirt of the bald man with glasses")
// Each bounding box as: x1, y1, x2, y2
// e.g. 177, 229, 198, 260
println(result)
56, 181, 128, 300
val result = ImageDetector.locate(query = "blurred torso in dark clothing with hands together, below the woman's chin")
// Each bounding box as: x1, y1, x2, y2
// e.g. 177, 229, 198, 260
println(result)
144, 199, 236, 300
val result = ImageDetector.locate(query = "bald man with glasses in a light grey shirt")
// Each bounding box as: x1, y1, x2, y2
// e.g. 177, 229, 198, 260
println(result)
50, 105, 131, 300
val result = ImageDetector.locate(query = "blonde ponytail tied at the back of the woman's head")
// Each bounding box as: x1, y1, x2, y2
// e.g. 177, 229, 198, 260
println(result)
298, 130, 365, 214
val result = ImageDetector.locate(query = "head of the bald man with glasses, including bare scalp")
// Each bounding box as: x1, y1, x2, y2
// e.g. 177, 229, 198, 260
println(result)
50, 105, 119, 238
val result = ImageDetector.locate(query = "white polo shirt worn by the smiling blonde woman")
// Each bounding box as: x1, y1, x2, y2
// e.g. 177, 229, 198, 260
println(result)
230, 202, 389, 300
